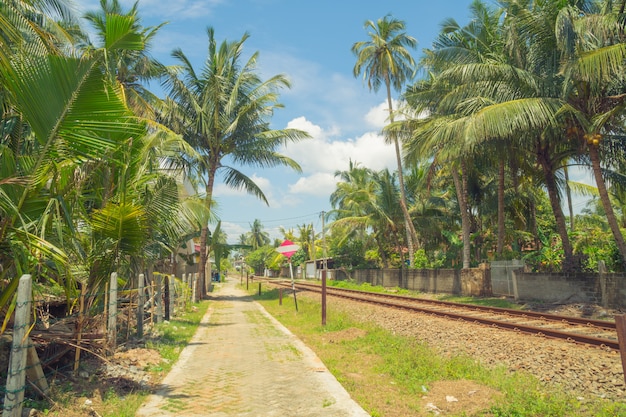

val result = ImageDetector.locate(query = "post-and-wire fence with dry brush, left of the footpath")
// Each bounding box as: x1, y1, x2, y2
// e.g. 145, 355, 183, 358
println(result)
0, 272, 198, 417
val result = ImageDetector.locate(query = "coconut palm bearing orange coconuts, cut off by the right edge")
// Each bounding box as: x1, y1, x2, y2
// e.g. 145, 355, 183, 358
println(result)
556, 2, 626, 266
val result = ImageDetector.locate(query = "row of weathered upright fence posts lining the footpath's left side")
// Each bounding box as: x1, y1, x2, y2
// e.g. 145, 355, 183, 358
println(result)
0, 272, 198, 417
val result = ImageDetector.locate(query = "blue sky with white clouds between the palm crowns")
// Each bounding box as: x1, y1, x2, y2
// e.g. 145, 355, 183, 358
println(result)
79, 0, 588, 243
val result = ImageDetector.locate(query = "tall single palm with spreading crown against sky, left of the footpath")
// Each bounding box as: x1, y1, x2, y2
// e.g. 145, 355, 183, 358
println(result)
162, 28, 308, 298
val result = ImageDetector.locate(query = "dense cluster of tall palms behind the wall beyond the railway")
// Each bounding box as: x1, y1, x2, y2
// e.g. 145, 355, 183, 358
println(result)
331, 0, 626, 270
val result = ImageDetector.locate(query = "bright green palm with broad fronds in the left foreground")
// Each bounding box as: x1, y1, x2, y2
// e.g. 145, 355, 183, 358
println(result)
0, 2, 161, 308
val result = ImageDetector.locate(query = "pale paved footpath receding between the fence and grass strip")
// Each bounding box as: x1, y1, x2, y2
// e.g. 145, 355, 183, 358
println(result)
137, 278, 369, 417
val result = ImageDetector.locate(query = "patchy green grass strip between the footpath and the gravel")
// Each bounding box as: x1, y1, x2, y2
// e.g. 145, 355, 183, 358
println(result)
250, 282, 626, 417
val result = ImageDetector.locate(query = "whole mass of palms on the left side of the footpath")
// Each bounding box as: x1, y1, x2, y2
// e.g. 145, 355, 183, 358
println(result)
0, 0, 306, 308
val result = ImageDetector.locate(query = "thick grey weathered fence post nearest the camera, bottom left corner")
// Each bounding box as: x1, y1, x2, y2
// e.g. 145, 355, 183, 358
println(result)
2, 274, 33, 417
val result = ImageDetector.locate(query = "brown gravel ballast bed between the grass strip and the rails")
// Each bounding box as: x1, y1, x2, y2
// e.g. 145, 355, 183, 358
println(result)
312, 290, 626, 401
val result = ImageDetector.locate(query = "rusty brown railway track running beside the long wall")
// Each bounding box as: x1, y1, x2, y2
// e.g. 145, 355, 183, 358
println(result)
260, 280, 619, 350
